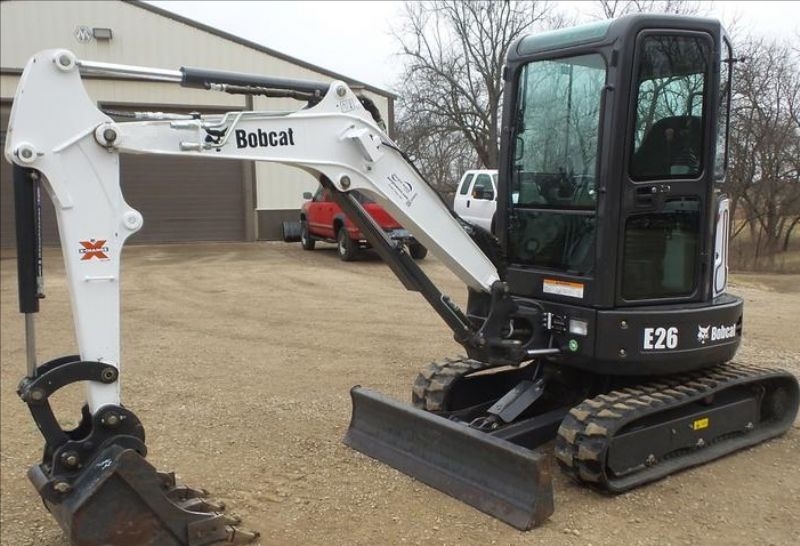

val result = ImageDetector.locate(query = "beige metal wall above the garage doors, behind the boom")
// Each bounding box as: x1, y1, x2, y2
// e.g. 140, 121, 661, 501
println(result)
0, 0, 391, 125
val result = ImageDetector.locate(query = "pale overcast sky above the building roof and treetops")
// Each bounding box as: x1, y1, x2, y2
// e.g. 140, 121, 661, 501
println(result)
148, 0, 800, 92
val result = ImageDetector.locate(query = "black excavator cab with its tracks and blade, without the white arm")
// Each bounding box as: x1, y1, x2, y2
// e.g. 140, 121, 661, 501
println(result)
354, 15, 798, 529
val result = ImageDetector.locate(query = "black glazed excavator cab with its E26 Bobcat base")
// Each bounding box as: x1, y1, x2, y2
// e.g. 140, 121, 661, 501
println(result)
468, 16, 742, 375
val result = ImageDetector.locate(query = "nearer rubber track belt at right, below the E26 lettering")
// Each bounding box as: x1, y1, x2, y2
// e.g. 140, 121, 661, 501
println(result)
555, 363, 797, 492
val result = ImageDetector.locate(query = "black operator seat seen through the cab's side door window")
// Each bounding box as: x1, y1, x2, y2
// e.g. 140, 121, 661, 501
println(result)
631, 116, 703, 180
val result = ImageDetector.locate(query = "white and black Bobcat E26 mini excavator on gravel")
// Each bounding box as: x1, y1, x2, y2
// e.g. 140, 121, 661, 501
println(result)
5, 15, 798, 545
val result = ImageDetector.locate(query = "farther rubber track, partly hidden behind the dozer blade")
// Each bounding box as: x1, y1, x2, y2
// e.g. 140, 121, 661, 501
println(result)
411, 356, 493, 412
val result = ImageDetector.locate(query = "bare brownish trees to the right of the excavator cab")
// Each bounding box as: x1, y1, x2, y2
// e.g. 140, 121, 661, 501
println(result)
726, 39, 800, 269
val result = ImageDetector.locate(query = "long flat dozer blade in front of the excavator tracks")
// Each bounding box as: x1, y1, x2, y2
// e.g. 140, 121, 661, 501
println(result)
344, 386, 553, 530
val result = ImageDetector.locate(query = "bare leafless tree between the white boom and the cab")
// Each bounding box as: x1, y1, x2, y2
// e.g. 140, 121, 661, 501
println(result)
395, 0, 559, 178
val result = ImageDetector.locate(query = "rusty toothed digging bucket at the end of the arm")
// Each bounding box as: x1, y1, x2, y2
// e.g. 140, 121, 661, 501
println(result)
28, 445, 258, 546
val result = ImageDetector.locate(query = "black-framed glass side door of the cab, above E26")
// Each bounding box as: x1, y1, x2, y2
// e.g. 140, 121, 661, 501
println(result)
617, 30, 716, 305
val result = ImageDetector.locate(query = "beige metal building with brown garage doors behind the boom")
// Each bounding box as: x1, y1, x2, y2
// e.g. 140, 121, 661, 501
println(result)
0, 0, 395, 248
